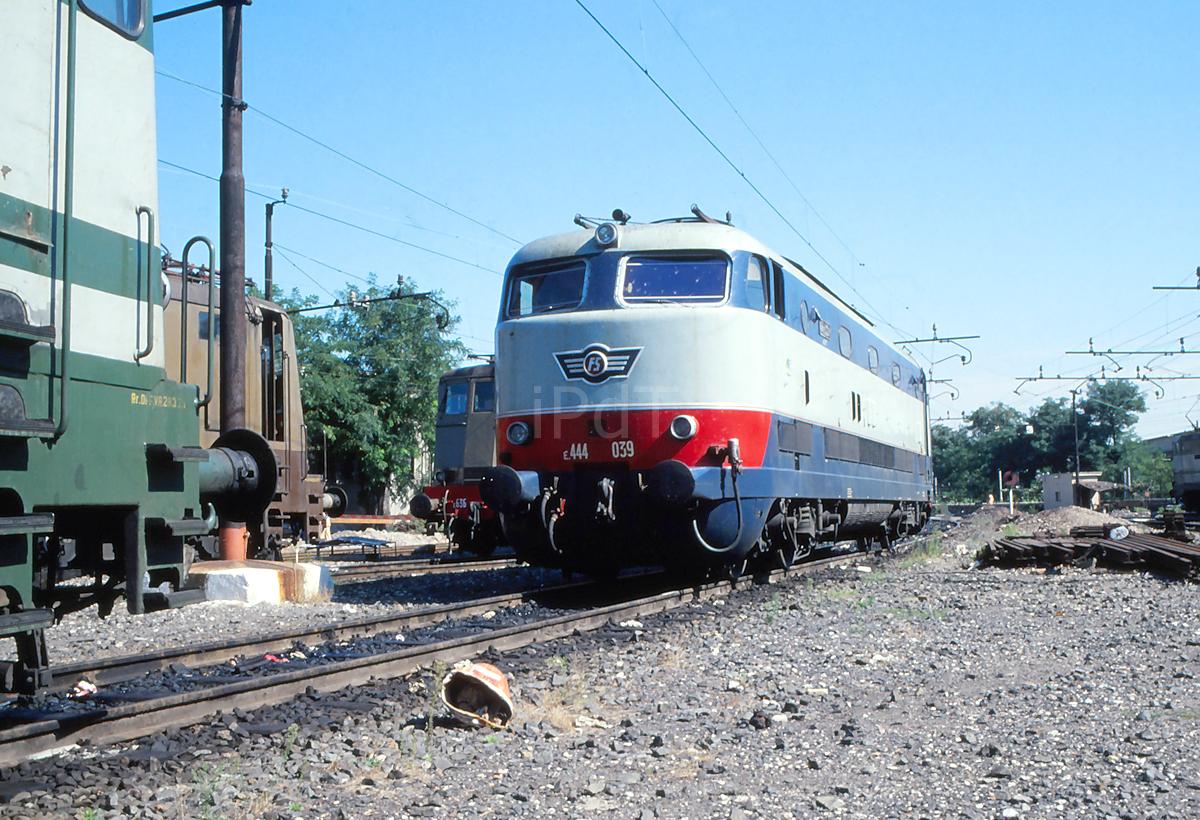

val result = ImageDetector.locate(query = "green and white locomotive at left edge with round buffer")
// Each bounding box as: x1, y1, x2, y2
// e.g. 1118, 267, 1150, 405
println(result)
0, 0, 277, 689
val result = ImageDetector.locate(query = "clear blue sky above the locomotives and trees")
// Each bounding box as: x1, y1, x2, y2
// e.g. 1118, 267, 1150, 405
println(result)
155, 0, 1200, 435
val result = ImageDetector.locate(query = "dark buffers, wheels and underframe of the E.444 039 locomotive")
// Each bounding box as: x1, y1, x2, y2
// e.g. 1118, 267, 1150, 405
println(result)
492, 471, 929, 576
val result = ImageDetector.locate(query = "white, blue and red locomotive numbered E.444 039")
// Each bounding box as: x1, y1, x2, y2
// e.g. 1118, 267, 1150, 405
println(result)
482, 210, 931, 571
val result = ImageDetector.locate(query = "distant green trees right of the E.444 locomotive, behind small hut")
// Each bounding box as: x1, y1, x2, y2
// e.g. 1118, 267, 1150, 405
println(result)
932, 382, 1171, 501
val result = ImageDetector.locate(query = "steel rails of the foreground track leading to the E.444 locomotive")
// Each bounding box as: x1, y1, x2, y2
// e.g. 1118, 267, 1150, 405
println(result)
0, 552, 862, 766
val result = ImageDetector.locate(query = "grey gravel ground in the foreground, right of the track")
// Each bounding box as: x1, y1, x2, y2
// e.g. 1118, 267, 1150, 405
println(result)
0, 516, 1200, 818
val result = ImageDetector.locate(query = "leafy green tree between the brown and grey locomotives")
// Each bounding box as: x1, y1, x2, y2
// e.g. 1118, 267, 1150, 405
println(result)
280, 279, 467, 508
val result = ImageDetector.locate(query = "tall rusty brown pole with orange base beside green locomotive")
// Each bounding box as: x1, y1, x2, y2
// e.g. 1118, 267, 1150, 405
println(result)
220, 0, 246, 559
